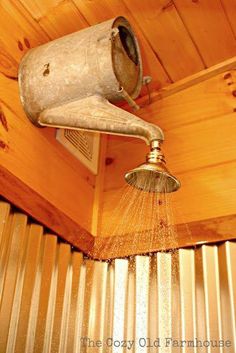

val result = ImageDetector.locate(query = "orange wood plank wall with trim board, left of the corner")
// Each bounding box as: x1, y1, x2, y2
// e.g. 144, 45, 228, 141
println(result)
0, 68, 95, 240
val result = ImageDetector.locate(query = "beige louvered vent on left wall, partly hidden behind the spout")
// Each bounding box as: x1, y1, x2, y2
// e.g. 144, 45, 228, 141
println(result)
56, 129, 100, 174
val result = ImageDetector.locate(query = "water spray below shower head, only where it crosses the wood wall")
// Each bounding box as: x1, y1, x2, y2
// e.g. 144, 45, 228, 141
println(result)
98, 173, 183, 257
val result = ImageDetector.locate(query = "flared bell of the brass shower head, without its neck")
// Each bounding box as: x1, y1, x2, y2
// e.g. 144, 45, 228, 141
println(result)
125, 162, 180, 193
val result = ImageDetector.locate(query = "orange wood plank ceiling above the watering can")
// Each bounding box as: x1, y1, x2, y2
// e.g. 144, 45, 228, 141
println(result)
0, 0, 236, 89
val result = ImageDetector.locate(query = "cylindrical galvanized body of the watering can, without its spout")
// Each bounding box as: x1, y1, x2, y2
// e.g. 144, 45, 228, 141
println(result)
19, 17, 142, 124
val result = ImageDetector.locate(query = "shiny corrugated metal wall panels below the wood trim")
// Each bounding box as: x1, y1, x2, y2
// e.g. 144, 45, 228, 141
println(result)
0, 202, 236, 353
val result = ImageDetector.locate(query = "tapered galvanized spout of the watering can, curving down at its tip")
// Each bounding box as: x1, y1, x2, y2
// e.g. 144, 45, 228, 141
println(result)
37, 95, 164, 145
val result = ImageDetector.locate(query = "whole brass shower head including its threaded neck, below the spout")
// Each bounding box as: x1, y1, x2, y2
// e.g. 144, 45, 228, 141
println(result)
125, 140, 180, 192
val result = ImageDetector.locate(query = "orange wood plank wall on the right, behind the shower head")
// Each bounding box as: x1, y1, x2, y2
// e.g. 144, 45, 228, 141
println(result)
99, 70, 236, 235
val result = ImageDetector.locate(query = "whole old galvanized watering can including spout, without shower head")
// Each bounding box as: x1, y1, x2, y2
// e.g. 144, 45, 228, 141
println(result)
19, 17, 164, 144
